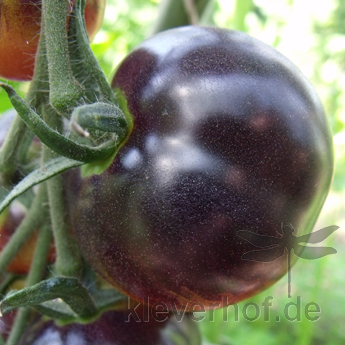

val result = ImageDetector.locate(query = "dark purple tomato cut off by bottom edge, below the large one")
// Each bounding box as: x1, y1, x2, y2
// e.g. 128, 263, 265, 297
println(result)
18, 311, 201, 345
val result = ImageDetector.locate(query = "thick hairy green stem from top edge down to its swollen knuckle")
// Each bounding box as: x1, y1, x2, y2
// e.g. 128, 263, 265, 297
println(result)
42, 0, 84, 118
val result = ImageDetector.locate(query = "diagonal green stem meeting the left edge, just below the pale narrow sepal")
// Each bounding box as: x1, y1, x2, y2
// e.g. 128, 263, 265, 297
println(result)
0, 185, 47, 272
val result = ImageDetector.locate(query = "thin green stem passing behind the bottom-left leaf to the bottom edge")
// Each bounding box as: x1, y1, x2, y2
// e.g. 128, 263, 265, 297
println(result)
7, 220, 52, 345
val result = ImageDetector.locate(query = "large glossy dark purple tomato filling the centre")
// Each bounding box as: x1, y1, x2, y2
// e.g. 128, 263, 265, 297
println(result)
69, 27, 333, 309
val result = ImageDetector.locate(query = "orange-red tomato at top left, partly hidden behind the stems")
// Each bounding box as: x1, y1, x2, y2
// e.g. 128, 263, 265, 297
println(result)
0, 0, 106, 80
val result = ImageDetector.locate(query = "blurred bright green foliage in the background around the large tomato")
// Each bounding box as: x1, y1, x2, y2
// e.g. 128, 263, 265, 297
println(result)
0, 0, 345, 345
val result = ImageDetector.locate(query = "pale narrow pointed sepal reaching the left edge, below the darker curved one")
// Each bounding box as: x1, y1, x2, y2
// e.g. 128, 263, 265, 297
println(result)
0, 157, 83, 213
